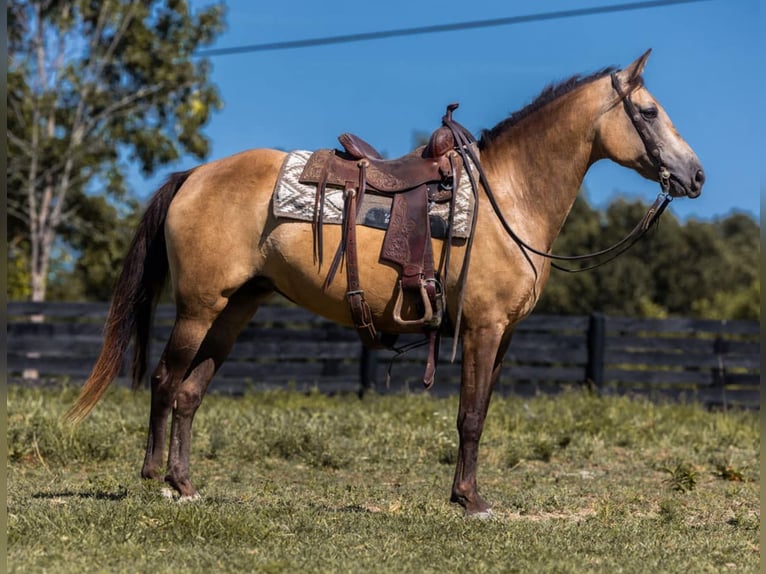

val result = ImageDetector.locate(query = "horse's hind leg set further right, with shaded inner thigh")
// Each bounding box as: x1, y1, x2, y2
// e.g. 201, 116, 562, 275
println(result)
165, 280, 271, 499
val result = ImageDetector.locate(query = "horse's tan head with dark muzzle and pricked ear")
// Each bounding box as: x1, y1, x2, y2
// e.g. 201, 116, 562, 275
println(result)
596, 50, 705, 197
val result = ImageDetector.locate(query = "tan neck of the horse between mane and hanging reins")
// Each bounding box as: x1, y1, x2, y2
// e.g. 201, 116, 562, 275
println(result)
482, 90, 599, 250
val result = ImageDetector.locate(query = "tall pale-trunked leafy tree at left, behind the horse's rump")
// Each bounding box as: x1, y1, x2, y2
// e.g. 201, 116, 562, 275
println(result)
7, 0, 223, 301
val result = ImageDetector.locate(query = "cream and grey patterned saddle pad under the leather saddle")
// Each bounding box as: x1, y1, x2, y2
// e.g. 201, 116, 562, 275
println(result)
272, 150, 478, 239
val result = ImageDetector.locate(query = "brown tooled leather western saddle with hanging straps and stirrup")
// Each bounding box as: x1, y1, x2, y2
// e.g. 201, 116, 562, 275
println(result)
300, 104, 476, 388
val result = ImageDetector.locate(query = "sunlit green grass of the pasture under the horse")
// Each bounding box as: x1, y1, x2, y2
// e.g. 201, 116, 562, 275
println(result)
8, 387, 760, 574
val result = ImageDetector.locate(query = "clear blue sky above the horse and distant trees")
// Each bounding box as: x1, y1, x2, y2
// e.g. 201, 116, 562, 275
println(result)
146, 0, 764, 220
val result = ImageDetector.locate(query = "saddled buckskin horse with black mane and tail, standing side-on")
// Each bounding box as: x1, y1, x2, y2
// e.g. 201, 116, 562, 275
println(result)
68, 50, 705, 517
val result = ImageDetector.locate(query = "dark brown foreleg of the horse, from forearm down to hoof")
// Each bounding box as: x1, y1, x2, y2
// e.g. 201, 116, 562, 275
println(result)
451, 327, 511, 516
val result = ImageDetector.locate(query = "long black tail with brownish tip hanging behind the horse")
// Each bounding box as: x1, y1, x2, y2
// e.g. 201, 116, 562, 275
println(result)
67, 170, 193, 422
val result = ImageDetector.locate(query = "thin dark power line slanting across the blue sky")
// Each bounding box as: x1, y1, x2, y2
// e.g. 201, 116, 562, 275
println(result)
195, 0, 709, 58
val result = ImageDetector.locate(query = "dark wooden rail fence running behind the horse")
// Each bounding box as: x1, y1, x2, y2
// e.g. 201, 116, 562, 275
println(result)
7, 303, 760, 408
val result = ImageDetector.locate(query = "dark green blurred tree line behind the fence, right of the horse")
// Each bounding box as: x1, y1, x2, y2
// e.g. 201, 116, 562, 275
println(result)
536, 194, 760, 319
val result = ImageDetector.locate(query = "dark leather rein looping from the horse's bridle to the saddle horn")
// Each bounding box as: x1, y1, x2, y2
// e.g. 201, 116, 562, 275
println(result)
442, 72, 673, 276
